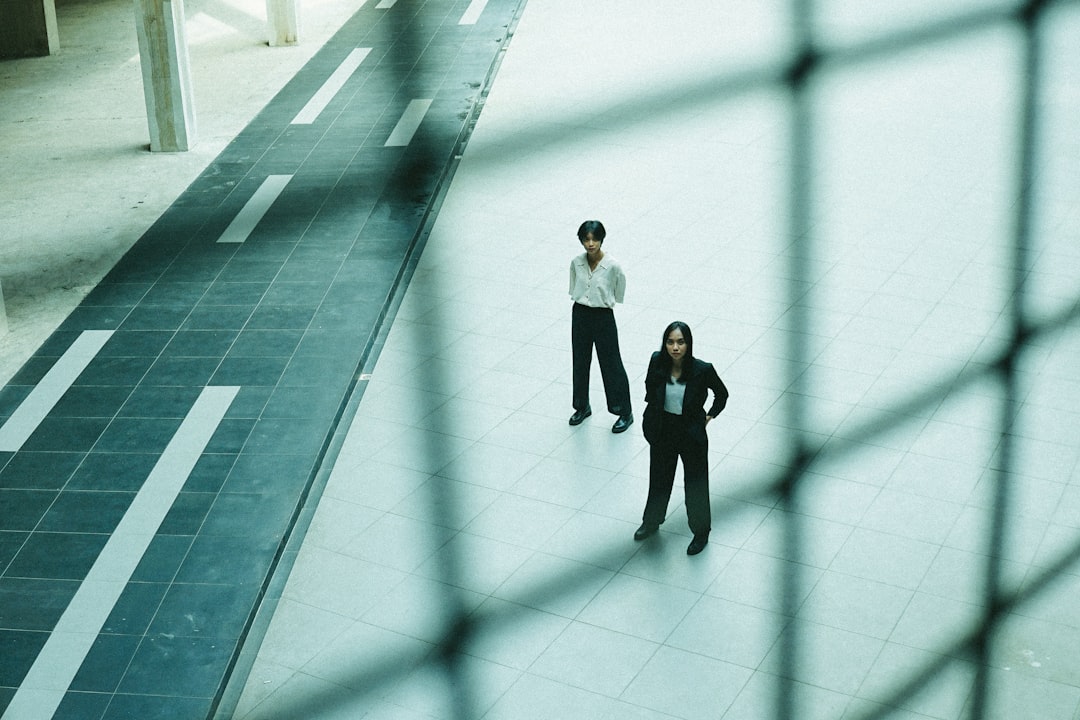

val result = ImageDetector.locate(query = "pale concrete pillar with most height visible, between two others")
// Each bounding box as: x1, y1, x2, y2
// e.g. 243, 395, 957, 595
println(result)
135, 0, 195, 152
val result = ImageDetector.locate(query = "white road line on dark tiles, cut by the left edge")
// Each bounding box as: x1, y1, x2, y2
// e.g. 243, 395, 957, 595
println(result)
0, 330, 112, 452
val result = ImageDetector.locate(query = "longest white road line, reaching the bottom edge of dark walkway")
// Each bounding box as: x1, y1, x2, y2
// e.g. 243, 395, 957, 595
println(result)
2, 386, 240, 720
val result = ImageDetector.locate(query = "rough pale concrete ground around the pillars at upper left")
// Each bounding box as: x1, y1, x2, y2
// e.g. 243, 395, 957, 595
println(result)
0, 0, 363, 384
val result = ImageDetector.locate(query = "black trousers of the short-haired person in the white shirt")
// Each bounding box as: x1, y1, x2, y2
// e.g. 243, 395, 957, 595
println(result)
570, 302, 631, 416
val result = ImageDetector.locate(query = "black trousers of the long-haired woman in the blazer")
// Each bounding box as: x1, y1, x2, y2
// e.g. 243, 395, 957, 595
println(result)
642, 412, 713, 535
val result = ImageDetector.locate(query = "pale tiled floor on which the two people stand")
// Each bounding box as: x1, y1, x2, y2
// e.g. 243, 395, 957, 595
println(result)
230, 2, 1080, 720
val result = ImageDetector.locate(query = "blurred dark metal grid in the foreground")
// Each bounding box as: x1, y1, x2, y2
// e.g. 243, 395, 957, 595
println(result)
267, 0, 1080, 720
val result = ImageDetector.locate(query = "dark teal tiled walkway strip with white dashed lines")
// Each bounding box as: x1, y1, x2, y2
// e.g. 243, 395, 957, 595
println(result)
0, 0, 527, 720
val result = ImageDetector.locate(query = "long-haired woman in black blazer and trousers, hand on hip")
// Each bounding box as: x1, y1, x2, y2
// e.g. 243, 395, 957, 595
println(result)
634, 321, 728, 555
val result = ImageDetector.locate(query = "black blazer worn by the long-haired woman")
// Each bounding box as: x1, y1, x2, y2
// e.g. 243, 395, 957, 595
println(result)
642, 352, 728, 445
